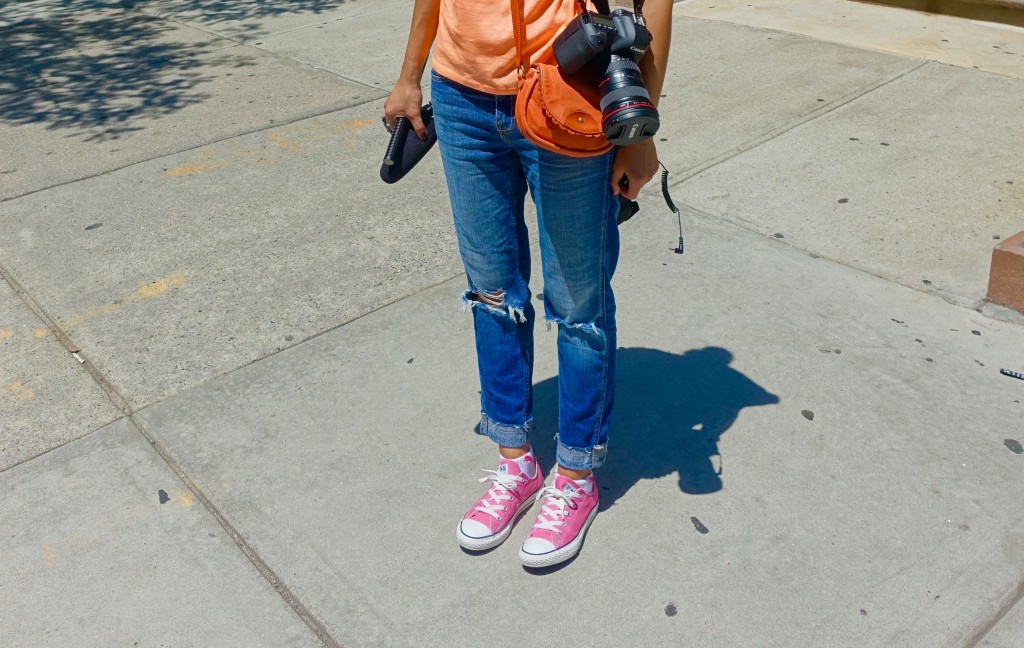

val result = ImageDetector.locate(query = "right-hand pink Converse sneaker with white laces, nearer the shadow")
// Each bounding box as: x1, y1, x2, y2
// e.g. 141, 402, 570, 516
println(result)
519, 472, 598, 567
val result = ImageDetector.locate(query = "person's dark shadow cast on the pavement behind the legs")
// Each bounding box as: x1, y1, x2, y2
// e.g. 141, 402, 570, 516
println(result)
532, 347, 779, 510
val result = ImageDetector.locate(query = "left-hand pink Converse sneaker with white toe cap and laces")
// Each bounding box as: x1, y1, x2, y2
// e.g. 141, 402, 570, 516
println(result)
456, 452, 544, 551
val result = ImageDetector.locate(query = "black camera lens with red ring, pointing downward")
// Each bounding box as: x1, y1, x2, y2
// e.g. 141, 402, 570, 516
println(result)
600, 54, 660, 146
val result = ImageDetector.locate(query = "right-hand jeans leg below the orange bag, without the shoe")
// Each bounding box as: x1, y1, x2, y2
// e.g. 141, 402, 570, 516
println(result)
526, 144, 618, 478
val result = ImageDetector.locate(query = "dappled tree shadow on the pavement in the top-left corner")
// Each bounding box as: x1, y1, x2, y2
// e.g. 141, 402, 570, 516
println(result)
0, 0, 348, 141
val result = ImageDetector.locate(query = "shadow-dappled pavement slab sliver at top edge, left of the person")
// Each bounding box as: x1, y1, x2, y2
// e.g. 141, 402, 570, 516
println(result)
138, 0, 413, 44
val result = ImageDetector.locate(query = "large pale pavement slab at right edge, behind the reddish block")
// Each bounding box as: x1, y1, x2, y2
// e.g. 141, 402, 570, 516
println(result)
677, 63, 1024, 306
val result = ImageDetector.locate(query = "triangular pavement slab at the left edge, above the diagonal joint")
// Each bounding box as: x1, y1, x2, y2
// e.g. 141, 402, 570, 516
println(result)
0, 272, 121, 471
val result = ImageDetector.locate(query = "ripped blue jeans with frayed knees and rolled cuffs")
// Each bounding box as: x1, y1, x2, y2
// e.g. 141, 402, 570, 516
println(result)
431, 73, 618, 470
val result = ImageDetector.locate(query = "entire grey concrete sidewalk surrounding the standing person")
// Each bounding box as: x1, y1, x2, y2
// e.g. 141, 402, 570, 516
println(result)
0, 0, 1024, 648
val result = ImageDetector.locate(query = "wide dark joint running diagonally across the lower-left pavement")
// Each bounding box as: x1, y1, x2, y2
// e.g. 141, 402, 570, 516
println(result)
0, 264, 342, 648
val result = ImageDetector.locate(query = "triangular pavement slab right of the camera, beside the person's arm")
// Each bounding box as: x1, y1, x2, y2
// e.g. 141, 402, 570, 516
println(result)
657, 15, 921, 173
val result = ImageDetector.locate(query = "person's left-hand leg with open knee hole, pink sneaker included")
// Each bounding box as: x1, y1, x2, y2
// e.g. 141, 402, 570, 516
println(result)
431, 75, 543, 550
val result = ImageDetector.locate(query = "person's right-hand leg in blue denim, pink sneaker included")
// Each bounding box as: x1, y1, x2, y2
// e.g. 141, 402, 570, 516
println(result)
519, 138, 618, 567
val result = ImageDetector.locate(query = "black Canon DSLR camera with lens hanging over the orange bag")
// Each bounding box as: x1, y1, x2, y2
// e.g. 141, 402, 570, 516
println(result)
554, 0, 660, 146
